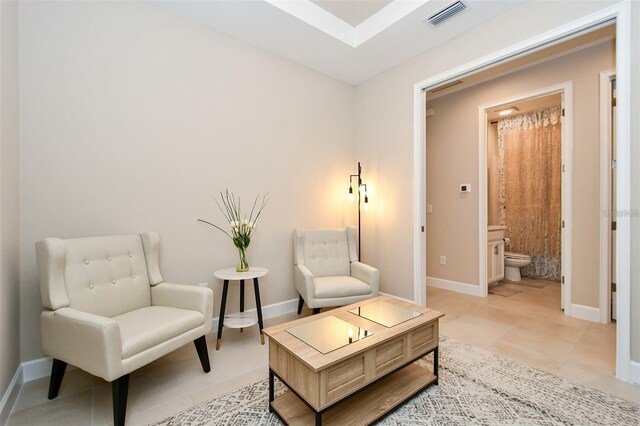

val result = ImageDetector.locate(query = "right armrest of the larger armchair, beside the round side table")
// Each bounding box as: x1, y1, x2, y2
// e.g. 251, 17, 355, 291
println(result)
151, 283, 213, 324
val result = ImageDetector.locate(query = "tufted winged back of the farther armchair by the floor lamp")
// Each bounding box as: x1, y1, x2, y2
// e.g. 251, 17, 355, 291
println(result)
293, 226, 358, 277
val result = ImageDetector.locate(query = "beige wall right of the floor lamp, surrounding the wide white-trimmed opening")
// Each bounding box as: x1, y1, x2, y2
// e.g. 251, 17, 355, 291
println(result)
356, 1, 640, 360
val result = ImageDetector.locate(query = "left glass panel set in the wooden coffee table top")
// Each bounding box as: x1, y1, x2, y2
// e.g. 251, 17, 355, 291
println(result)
286, 315, 373, 354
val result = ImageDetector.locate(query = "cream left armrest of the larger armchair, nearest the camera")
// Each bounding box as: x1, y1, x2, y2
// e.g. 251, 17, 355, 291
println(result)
40, 308, 122, 381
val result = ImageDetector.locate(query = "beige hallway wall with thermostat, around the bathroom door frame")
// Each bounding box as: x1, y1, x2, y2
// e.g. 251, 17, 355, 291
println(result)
427, 41, 615, 308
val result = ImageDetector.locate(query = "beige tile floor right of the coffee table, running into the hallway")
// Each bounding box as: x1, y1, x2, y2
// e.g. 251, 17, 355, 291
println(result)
427, 279, 640, 403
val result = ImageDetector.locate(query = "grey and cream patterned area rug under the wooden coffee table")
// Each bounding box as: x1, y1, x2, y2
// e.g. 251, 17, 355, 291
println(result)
155, 336, 640, 426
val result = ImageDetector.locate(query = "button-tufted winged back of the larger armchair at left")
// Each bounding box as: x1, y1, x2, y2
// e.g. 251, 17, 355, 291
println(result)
36, 232, 162, 317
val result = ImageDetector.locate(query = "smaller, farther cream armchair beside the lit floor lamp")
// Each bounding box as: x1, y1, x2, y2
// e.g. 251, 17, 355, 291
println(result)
293, 226, 380, 315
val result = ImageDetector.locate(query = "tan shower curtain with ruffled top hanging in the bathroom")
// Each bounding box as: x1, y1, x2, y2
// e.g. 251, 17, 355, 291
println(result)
498, 107, 562, 280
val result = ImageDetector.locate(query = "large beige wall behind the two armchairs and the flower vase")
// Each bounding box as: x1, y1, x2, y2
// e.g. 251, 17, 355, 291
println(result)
20, 2, 356, 360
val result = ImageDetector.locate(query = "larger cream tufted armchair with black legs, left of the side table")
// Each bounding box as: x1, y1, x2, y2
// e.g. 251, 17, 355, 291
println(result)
36, 232, 213, 425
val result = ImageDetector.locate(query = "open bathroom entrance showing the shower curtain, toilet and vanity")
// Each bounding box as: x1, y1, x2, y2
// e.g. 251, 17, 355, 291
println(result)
481, 88, 570, 308
